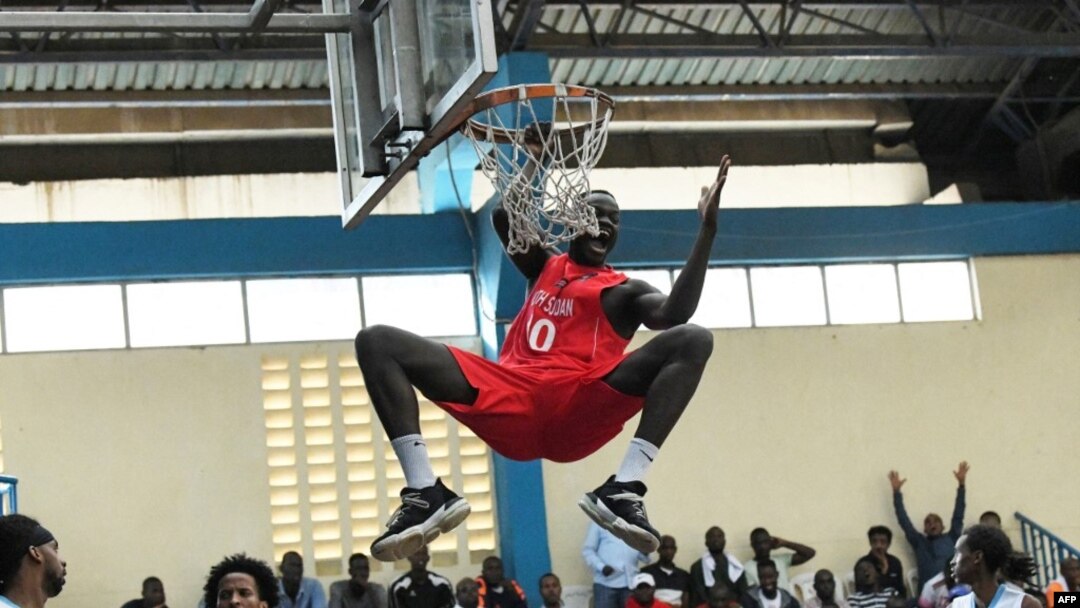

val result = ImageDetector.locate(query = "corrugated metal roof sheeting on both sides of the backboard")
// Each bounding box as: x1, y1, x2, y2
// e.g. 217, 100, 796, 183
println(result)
0, 4, 1059, 92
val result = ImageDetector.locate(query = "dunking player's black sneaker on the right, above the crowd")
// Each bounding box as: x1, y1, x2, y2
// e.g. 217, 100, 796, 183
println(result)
578, 475, 660, 553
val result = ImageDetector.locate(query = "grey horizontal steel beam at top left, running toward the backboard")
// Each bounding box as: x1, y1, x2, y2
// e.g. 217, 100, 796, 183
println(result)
0, 12, 351, 33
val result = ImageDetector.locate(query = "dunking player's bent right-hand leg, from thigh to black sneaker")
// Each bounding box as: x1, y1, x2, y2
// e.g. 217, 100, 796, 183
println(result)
578, 325, 713, 553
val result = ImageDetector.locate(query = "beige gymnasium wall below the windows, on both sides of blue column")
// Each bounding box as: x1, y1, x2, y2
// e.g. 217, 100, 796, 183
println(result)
0, 256, 1080, 608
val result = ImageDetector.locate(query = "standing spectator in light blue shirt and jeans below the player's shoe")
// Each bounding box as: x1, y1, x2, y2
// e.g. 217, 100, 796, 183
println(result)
581, 524, 649, 608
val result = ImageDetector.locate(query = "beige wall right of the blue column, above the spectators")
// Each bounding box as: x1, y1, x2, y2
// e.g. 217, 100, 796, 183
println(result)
543, 255, 1080, 592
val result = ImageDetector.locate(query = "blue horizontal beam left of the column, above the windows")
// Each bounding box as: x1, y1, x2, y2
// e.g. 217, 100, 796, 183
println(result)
0, 214, 473, 285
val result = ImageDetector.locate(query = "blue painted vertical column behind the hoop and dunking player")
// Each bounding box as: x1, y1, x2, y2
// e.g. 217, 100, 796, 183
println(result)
473, 53, 551, 606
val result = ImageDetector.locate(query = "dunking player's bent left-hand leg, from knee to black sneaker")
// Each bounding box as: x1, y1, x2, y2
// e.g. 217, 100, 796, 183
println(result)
356, 325, 476, 562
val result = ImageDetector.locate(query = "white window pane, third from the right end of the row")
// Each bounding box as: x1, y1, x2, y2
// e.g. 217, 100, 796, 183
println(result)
750, 266, 825, 327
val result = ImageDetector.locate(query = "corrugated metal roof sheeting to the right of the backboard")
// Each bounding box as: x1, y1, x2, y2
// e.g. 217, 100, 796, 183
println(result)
541, 4, 1058, 87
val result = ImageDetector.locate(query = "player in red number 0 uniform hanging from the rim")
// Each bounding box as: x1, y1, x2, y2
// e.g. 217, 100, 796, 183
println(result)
356, 151, 731, 560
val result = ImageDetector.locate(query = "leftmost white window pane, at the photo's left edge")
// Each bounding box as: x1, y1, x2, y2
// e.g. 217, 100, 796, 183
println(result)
4, 285, 125, 352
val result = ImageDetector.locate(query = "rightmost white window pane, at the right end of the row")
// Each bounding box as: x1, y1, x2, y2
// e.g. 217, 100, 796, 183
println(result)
896, 261, 975, 322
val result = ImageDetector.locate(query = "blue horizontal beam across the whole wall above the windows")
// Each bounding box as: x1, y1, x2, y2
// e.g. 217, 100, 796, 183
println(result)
0, 202, 1080, 285
